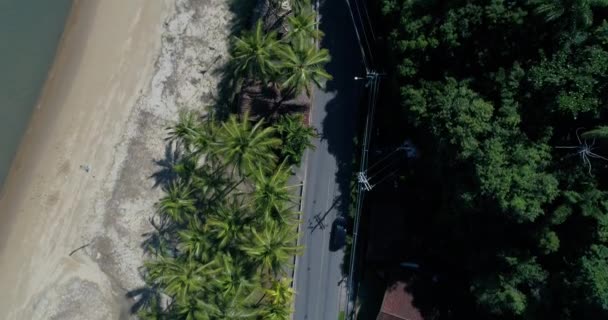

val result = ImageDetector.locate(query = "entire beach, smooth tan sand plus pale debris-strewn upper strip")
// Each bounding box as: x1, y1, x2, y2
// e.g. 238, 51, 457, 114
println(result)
0, 0, 234, 320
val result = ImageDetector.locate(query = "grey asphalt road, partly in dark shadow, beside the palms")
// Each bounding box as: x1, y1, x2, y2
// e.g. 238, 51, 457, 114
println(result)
294, 0, 364, 320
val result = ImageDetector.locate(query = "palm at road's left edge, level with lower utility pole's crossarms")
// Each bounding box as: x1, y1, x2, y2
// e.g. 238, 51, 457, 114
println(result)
251, 163, 291, 221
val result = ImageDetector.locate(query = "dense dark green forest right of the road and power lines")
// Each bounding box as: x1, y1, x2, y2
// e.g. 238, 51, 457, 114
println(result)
381, 0, 608, 319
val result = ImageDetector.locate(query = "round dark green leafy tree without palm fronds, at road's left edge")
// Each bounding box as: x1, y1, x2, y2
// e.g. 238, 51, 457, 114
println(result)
276, 114, 316, 166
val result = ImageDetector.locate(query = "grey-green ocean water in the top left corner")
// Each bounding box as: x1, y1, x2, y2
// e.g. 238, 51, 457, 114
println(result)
0, 0, 72, 189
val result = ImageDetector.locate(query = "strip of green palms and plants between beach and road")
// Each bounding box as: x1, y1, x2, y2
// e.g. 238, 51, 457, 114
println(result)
133, 1, 331, 320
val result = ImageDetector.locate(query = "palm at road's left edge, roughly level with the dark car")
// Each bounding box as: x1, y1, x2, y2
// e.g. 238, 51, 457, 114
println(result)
241, 222, 300, 275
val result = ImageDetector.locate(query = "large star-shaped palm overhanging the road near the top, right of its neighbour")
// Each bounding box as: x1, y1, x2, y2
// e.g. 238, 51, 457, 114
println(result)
278, 43, 332, 96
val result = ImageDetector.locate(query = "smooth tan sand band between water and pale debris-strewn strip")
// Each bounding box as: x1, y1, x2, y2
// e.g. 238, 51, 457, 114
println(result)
0, 0, 164, 319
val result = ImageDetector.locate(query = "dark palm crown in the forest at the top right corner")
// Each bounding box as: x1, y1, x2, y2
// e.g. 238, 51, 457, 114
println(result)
531, 0, 608, 31
